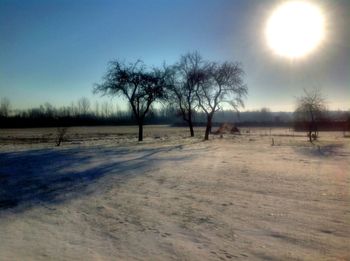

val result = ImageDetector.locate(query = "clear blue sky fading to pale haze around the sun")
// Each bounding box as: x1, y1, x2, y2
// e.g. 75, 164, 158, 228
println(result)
0, 0, 350, 111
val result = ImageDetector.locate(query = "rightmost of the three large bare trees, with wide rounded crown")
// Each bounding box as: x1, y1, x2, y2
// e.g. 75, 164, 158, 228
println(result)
196, 62, 248, 140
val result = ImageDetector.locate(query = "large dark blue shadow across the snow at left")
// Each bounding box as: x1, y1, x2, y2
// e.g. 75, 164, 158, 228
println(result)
0, 146, 189, 211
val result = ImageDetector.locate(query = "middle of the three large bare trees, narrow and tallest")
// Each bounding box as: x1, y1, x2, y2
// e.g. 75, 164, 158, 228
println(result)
169, 52, 204, 137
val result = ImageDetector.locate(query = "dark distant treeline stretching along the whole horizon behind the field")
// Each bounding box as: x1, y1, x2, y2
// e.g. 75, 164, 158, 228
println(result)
0, 98, 350, 131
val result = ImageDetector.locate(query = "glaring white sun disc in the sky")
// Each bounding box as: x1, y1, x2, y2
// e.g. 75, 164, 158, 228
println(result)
265, 1, 325, 58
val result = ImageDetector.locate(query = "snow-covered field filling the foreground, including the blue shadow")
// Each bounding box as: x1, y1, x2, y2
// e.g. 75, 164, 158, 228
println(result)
0, 126, 350, 260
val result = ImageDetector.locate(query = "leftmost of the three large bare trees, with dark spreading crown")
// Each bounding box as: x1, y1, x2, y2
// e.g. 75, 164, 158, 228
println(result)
94, 60, 168, 141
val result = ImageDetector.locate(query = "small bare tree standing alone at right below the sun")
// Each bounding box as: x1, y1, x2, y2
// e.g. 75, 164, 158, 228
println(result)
295, 89, 326, 142
